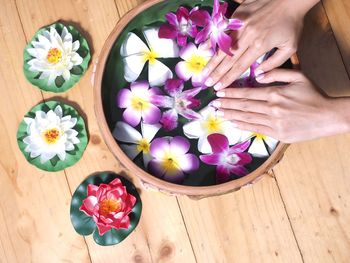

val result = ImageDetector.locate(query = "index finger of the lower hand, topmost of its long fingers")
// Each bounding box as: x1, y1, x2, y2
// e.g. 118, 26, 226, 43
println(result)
216, 87, 275, 101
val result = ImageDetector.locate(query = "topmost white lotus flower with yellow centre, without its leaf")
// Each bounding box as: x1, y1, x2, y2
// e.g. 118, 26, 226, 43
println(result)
27, 27, 83, 85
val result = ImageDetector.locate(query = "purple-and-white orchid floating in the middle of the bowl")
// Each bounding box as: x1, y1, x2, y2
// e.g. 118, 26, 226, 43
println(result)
153, 79, 202, 131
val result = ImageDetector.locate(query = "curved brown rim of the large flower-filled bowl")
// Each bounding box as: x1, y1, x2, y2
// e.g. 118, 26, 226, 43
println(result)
93, 0, 299, 196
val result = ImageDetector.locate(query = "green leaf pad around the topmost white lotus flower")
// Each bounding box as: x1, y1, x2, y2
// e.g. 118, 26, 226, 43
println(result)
23, 23, 91, 93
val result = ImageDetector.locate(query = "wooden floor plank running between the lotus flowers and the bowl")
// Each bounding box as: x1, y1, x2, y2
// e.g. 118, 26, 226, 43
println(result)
18, 0, 194, 262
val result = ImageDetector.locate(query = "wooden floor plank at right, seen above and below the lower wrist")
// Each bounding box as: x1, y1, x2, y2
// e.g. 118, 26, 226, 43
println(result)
274, 4, 350, 262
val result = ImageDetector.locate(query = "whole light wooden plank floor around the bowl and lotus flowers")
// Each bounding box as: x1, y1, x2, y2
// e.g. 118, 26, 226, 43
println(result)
0, 0, 350, 263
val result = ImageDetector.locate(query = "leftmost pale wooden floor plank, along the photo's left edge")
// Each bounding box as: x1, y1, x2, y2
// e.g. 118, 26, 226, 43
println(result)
0, 0, 89, 263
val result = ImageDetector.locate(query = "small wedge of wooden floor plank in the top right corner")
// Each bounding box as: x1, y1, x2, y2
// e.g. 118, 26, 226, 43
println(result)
322, 0, 350, 76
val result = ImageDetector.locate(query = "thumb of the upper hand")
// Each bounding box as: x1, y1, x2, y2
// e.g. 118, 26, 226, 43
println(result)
255, 48, 295, 75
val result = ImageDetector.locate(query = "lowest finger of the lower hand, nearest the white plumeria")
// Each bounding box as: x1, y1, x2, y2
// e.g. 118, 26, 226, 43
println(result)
218, 109, 271, 126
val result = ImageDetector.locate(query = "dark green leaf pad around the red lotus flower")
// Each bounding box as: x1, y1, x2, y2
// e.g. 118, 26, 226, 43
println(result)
70, 172, 142, 246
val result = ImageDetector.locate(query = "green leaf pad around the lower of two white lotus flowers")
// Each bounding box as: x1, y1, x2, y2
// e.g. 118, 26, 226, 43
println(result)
17, 100, 88, 172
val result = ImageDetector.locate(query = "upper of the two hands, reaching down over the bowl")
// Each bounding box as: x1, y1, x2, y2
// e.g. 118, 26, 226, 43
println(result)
203, 0, 312, 90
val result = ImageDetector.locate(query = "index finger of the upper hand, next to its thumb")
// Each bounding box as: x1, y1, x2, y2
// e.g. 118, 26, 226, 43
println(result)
214, 48, 264, 90
